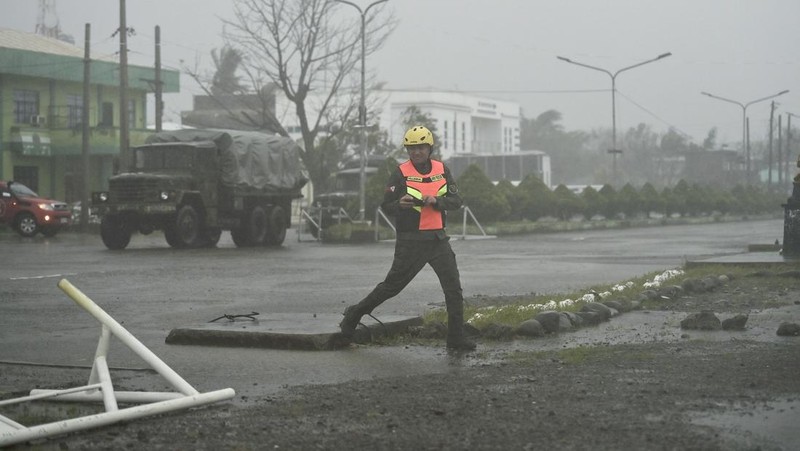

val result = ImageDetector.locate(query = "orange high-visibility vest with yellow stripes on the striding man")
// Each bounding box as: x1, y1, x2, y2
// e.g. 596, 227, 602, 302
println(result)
400, 160, 447, 230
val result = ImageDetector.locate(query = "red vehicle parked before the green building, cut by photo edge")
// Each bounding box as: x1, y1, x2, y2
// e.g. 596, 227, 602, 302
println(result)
0, 181, 72, 237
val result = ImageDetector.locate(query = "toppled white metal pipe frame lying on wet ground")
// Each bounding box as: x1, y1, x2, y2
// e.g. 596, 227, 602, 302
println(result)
0, 279, 236, 447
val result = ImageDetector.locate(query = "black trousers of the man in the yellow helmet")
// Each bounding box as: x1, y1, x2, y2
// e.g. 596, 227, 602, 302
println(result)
358, 239, 464, 314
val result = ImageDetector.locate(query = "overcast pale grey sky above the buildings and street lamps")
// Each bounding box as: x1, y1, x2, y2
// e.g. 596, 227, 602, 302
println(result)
0, 0, 800, 147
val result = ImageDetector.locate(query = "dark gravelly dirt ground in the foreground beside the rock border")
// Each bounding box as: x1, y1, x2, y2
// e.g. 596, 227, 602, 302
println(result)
3, 271, 800, 450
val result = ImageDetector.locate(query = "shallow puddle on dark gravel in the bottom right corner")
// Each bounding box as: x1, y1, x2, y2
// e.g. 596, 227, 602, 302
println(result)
691, 399, 800, 450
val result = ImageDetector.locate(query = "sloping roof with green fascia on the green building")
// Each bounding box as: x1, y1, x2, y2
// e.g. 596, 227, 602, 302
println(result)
0, 28, 180, 92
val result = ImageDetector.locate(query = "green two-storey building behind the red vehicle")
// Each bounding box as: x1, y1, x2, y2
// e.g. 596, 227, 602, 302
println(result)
0, 29, 179, 202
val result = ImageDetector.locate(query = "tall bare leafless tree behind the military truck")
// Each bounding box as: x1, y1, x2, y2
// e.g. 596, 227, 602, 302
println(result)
224, 0, 395, 191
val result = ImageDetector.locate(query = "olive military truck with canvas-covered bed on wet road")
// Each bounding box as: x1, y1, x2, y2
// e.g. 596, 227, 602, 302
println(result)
92, 130, 308, 250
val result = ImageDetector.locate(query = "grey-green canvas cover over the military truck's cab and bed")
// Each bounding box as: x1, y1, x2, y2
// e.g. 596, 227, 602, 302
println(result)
146, 129, 308, 191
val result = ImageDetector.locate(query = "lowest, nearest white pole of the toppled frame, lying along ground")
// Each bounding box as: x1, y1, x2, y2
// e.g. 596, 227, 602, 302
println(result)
0, 388, 235, 447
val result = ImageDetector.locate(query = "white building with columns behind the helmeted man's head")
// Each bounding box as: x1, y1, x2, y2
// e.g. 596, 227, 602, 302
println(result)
375, 90, 521, 160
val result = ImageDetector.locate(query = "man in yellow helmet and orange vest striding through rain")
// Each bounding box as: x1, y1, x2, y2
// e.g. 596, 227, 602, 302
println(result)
339, 126, 475, 350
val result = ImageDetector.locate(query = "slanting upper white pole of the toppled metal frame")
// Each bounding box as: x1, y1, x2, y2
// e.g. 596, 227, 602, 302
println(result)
58, 279, 198, 395
